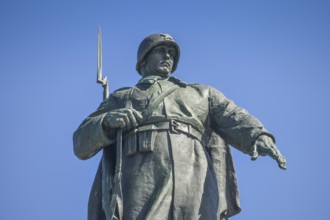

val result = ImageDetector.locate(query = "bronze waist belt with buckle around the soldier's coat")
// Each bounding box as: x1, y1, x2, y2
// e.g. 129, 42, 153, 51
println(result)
124, 120, 203, 140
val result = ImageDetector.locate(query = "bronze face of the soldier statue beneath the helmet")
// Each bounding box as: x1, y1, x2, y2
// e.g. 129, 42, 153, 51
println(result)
145, 45, 176, 76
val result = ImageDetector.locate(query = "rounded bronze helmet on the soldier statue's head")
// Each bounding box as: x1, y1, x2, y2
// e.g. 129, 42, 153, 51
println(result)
136, 34, 180, 75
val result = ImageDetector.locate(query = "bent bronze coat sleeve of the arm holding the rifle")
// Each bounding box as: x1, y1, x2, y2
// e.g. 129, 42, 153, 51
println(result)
73, 95, 117, 160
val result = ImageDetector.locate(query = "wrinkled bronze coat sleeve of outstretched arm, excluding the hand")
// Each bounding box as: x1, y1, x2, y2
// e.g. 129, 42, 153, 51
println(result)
209, 88, 275, 153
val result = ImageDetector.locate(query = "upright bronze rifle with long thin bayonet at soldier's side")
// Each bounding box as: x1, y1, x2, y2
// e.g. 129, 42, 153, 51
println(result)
96, 26, 123, 220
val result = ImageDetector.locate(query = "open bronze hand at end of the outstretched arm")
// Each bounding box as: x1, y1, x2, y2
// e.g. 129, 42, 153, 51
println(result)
251, 135, 286, 170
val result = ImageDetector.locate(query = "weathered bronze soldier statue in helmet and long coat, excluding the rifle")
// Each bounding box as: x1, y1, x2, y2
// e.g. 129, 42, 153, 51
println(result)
73, 34, 286, 220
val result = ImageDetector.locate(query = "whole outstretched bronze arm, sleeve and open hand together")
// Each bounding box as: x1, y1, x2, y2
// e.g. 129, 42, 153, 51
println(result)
210, 89, 286, 169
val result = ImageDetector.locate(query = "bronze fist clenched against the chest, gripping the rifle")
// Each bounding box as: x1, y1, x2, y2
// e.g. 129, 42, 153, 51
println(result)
102, 108, 142, 130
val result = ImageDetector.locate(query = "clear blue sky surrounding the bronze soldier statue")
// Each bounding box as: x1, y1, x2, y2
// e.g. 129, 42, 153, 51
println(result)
0, 0, 330, 220
